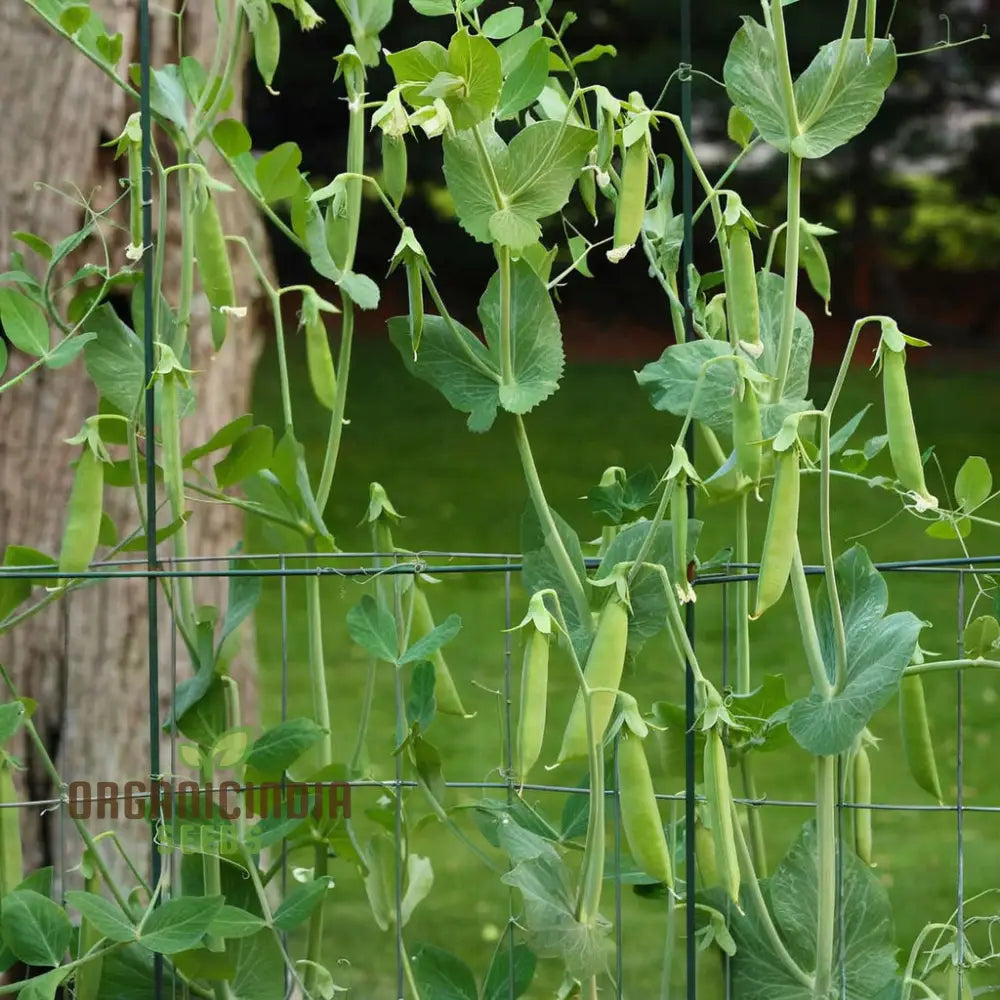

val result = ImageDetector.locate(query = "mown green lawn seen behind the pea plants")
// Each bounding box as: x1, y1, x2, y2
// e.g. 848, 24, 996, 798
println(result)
250, 332, 1000, 1000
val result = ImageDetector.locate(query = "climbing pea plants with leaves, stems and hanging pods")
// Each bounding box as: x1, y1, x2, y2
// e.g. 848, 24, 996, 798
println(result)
0, 0, 1000, 1000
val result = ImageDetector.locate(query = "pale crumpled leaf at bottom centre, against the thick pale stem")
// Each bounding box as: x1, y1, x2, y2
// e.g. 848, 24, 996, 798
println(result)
499, 823, 609, 981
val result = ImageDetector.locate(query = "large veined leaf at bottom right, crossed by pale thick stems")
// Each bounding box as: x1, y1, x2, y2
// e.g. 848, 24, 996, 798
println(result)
716, 821, 896, 1000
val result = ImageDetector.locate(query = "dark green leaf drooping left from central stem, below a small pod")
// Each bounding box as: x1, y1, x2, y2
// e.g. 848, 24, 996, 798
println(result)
389, 316, 500, 432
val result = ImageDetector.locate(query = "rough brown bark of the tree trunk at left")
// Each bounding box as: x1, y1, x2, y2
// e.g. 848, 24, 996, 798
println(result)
0, 0, 265, 892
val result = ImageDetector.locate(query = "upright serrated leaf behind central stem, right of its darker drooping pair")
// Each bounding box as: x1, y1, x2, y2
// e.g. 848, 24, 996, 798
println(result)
478, 260, 565, 413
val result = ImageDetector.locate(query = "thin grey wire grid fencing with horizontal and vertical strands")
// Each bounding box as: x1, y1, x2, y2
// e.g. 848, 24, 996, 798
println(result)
0, 549, 1000, 1000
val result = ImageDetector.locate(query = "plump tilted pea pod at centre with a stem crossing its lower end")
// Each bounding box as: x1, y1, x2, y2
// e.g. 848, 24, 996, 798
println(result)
558, 594, 628, 764
